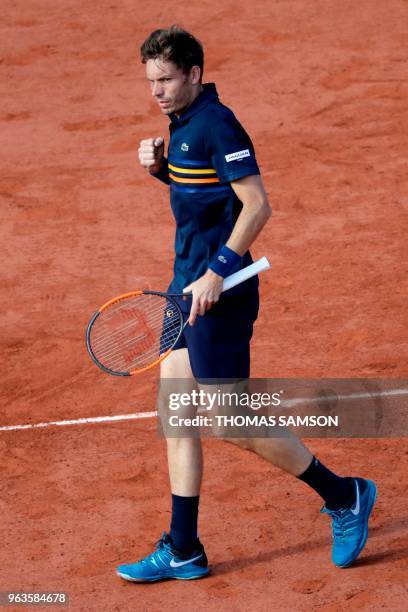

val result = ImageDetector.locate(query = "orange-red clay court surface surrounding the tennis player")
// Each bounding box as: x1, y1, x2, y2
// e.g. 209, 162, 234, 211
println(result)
0, 0, 408, 612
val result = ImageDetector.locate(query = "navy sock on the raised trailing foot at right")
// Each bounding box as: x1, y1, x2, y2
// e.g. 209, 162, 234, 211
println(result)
298, 457, 356, 510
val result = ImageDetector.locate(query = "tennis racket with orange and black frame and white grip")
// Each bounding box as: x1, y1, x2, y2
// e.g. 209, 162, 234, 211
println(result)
86, 257, 270, 376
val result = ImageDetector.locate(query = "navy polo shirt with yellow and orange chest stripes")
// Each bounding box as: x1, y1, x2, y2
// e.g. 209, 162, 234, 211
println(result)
151, 83, 260, 294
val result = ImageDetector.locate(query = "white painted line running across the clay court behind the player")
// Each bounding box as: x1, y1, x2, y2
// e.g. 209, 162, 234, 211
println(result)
0, 389, 408, 431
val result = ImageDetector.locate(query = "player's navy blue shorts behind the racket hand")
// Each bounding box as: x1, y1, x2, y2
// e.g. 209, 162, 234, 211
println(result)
173, 291, 259, 379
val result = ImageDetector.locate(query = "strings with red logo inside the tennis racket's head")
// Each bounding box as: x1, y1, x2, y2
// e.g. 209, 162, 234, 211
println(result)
89, 294, 183, 372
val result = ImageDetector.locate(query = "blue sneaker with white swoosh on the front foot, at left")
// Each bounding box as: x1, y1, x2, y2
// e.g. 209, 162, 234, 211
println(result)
116, 533, 208, 582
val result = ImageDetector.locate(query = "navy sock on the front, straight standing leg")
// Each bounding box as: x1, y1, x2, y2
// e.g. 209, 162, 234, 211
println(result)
170, 495, 200, 553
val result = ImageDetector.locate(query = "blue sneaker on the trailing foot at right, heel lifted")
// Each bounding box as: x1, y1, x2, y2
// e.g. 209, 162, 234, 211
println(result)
320, 478, 377, 567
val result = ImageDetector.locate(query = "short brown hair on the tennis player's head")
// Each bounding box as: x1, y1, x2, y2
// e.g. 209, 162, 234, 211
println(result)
140, 25, 204, 76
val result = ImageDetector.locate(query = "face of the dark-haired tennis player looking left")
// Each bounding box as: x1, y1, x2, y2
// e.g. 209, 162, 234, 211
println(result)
146, 58, 199, 115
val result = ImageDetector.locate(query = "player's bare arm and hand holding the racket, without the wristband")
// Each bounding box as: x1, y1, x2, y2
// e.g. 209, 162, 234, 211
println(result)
184, 174, 271, 325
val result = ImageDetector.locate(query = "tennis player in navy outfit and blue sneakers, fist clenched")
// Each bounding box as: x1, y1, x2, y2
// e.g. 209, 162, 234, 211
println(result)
117, 26, 376, 582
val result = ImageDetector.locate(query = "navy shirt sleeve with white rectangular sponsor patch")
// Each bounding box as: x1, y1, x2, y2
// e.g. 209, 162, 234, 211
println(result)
207, 108, 260, 183
